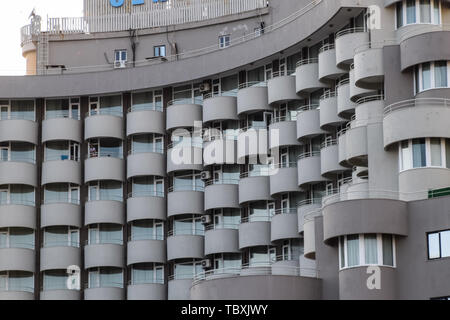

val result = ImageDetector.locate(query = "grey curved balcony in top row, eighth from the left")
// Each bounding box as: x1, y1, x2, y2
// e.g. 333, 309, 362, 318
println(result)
267, 71, 301, 104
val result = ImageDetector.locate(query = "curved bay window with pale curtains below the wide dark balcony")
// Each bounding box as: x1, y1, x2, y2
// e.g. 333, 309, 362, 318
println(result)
339, 234, 395, 269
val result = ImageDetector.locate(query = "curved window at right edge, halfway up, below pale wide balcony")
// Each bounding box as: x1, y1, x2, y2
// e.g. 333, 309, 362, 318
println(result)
399, 138, 450, 171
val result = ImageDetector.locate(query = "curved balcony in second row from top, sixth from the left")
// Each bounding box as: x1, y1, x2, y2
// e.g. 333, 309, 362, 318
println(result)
203, 137, 238, 166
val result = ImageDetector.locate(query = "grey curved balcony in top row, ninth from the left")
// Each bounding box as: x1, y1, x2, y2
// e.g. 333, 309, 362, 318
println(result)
295, 58, 328, 96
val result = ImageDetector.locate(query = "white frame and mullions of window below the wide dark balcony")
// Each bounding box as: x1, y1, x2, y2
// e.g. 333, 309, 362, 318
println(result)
338, 233, 397, 270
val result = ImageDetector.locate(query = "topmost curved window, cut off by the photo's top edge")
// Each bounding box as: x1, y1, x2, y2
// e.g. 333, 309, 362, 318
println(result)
395, 0, 441, 28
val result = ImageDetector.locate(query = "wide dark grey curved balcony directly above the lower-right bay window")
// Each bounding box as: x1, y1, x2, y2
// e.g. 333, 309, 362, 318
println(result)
322, 198, 408, 241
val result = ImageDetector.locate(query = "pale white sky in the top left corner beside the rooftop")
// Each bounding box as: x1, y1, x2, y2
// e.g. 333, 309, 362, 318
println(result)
0, 0, 83, 76
